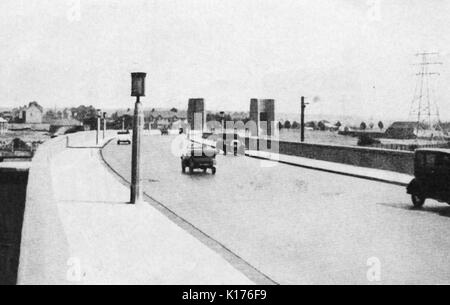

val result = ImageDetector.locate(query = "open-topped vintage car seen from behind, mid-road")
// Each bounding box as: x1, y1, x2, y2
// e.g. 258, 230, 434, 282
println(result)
181, 146, 217, 175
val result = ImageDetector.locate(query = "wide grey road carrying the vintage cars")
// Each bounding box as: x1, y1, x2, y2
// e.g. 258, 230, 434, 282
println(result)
103, 136, 450, 284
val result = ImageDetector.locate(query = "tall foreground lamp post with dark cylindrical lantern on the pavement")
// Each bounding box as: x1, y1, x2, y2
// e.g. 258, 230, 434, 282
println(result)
130, 72, 147, 204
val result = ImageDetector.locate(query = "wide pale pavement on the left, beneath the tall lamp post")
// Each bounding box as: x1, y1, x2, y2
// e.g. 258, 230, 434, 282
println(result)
19, 133, 253, 285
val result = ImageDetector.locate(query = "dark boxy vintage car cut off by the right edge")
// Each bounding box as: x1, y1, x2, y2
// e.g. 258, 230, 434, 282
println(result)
407, 149, 450, 208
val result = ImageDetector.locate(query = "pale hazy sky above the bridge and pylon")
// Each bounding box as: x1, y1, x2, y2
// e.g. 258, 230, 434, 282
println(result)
0, 0, 450, 120
